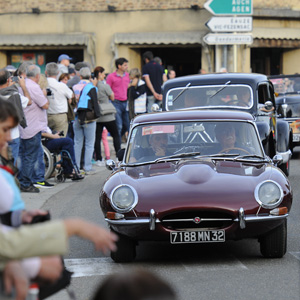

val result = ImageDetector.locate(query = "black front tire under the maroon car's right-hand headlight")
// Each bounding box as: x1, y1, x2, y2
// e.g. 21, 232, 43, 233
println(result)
260, 219, 287, 258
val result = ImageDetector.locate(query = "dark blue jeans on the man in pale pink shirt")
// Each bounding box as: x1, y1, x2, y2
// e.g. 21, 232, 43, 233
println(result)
19, 132, 45, 187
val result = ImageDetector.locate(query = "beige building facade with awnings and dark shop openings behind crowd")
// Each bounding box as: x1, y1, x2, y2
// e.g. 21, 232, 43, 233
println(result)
0, 0, 300, 75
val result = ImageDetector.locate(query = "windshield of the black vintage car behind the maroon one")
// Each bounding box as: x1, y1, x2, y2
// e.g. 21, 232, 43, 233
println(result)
166, 81, 253, 110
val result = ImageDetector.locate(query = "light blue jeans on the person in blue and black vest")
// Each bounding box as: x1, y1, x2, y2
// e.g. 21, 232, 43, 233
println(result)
73, 119, 96, 171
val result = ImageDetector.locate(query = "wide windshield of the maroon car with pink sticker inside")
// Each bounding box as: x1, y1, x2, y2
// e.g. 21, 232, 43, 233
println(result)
125, 121, 264, 163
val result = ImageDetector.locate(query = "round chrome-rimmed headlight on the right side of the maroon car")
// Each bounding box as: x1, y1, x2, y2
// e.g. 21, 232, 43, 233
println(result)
254, 180, 283, 209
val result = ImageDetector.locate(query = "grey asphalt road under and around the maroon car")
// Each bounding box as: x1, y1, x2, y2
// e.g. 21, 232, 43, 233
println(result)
22, 149, 300, 300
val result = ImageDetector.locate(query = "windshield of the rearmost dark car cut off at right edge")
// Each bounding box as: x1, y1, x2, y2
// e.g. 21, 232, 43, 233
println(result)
270, 76, 300, 95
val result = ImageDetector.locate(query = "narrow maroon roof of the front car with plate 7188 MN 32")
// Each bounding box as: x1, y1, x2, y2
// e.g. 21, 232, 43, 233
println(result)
132, 109, 254, 124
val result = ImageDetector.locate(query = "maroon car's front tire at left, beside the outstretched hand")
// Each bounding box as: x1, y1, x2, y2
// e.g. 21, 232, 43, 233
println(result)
110, 231, 136, 263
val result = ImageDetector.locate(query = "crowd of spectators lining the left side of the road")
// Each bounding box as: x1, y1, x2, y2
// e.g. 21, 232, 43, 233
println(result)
0, 52, 175, 299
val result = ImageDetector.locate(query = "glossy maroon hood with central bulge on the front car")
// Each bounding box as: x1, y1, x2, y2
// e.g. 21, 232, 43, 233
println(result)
104, 161, 288, 215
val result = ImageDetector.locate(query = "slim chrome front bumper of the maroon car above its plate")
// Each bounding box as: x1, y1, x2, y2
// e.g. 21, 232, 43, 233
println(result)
105, 208, 289, 230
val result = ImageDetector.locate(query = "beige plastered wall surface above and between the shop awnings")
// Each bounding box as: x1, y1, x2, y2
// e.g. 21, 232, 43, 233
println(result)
0, 0, 300, 72
